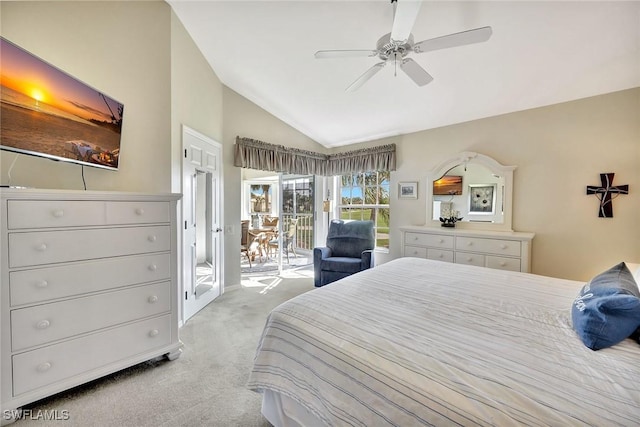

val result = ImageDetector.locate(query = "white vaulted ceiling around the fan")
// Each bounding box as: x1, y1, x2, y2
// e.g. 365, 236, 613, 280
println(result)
168, 0, 640, 147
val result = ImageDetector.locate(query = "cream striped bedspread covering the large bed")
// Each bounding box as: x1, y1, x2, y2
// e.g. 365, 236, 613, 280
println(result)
249, 258, 640, 427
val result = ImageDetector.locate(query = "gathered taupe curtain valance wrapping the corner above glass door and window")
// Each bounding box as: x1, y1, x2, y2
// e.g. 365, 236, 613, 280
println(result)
233, 137, 396, 176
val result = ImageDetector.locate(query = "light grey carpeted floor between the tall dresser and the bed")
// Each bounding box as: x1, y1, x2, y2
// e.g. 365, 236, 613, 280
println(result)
14, 266, 313, 427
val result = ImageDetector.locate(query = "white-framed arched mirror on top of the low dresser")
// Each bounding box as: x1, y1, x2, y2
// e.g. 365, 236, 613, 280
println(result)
426, 151, 516, 231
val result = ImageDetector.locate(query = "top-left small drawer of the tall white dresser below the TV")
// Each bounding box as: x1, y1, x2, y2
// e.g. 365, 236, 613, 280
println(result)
7, 200, 105, 230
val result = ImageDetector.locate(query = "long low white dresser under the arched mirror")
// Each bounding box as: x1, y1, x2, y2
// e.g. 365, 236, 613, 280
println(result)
400, 226, 534, 273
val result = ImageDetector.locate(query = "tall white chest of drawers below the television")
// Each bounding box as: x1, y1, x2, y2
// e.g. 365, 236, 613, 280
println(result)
0, 189, 182, 421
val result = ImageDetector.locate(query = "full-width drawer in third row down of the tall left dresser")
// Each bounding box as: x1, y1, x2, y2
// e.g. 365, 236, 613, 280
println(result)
9, 253, 171, 306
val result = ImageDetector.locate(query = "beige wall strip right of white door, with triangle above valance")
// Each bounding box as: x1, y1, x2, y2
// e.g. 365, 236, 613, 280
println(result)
223, 87, 327, 284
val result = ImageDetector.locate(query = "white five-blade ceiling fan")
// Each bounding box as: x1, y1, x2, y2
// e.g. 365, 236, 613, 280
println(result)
315, 0, 491, 92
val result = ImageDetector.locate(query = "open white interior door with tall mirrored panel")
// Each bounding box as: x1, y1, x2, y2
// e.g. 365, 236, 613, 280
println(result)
182, 126, 224, 323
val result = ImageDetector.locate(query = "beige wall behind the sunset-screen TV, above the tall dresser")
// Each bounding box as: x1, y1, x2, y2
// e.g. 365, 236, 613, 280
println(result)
0, 1, 171, 192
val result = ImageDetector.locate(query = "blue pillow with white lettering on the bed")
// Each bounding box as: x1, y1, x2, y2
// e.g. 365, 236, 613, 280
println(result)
571, 263, 640, 350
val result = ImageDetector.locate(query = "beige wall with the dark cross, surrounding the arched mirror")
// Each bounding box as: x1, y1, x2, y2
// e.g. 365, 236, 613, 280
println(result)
388, 89, 640, 280
